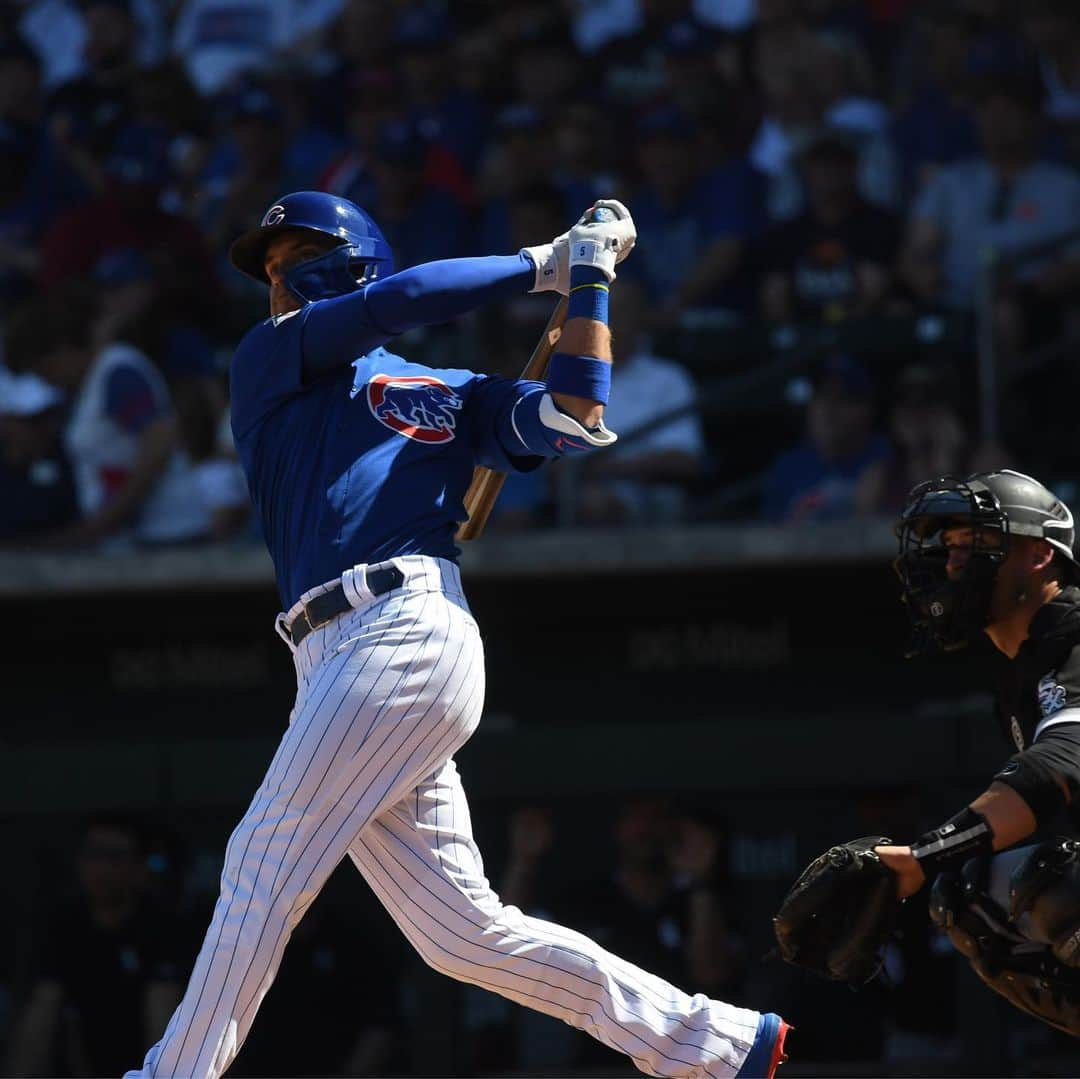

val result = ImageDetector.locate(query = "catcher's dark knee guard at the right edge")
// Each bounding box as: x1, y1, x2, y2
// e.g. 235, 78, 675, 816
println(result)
1009, 838, 1080, 967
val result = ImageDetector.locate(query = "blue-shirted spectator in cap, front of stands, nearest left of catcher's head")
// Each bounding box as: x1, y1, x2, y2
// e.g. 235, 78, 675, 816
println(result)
762, 355, 892, 524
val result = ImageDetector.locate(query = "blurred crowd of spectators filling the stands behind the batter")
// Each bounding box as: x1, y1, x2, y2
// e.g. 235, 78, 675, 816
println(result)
0, 0, 1080, 550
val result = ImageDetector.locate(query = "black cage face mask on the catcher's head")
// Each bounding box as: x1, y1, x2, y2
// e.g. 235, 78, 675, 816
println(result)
892, 476, 1009, 656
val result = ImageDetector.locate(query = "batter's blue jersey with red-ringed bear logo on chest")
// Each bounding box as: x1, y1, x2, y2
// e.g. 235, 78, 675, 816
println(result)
231, 300, 543, 609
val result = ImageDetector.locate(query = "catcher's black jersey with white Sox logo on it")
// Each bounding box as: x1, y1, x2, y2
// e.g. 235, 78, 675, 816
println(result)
995, 586, 1080, 828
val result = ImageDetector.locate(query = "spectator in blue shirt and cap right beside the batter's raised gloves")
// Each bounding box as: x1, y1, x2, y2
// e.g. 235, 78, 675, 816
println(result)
623, 106, 765, 325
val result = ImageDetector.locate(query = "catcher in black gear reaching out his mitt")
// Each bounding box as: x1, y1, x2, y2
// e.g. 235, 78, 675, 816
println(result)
774, 471, 1080, 1036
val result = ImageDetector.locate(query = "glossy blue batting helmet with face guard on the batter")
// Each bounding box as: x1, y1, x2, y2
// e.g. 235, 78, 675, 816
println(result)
229, 191, 394, 302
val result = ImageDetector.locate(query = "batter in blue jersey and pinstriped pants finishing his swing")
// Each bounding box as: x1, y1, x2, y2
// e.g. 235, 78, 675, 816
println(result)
124, 191, 786, 1079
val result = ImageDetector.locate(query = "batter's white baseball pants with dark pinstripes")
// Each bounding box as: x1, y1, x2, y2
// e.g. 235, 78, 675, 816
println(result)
129, 556, 758, 1079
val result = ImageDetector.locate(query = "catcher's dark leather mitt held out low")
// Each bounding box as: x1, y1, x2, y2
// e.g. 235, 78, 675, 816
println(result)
772, 836, 900, 985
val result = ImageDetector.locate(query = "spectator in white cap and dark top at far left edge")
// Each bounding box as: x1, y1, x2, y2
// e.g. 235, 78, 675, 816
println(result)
0, 367, 79, 545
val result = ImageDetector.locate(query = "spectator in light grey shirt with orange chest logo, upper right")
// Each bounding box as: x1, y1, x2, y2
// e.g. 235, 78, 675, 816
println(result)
902, 78, 1080, 360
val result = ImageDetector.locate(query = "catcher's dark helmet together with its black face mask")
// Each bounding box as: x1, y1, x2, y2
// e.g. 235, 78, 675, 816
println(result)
893, 469, 1080, 651
